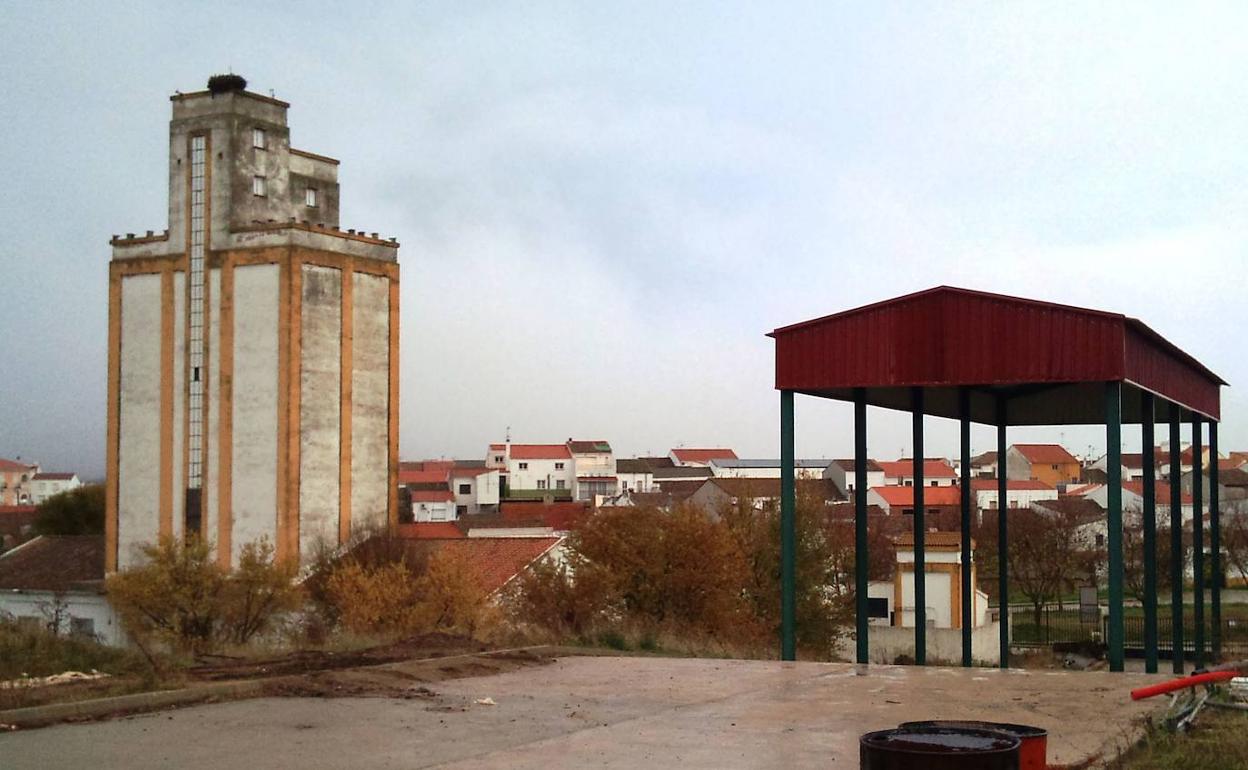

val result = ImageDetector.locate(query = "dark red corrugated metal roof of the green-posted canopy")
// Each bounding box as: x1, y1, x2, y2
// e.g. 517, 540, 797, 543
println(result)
770, 286, 1226, 426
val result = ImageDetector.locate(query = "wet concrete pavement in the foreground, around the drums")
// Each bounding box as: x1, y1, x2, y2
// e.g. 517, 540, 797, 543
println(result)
0, 658, 1164, 770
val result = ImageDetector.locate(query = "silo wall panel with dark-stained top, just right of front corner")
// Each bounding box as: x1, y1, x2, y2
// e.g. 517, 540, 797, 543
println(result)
300, 265, 342, 560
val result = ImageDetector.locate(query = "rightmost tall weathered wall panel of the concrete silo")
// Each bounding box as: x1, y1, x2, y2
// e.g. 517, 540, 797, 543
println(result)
351, 273, 389, 532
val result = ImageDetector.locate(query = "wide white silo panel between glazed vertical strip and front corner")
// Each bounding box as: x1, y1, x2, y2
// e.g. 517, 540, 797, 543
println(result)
231, 265, 278, 560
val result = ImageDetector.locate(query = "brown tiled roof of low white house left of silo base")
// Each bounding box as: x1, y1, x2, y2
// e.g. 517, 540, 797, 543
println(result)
0, 534, 104, 590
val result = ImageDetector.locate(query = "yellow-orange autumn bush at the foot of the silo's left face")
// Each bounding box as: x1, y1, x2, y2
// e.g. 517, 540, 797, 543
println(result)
106, 538, 302, 653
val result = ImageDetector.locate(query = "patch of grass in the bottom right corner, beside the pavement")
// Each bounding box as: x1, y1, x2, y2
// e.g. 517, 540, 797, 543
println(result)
1111, 708, 1248, 770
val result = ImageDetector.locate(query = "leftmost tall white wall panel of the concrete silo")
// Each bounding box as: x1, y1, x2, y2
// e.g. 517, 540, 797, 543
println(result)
117, 275, 161, 569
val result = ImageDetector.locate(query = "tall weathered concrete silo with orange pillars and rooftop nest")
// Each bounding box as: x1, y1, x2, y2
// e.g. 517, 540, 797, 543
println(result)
106, 75, 398, 570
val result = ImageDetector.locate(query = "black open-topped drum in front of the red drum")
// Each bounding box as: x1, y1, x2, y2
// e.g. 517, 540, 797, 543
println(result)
859, 728, 1022, 770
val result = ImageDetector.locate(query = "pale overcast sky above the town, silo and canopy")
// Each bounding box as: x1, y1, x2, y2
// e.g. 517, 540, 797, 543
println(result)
0, 0, 1248, 477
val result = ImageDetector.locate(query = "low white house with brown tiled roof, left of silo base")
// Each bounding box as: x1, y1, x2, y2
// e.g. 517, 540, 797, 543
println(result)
0, 535, 129, 646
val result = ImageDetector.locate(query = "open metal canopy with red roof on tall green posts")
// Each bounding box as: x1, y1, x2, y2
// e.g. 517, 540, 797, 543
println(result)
769, 286, 1227, 671
